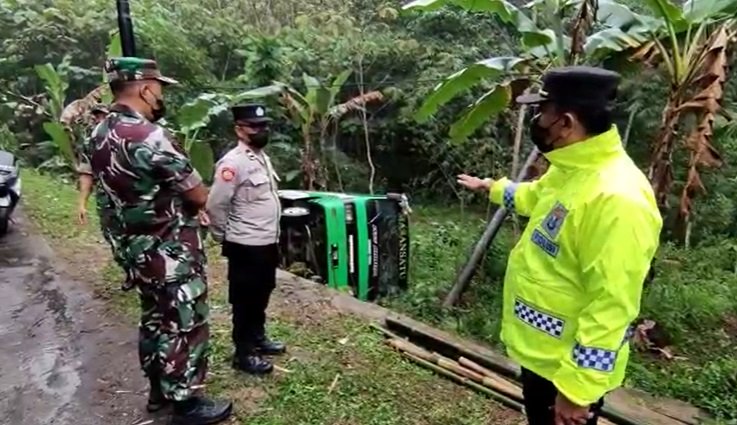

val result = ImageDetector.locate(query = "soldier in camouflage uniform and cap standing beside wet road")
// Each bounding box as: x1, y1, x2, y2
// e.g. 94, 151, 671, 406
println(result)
90, 57, 232, 425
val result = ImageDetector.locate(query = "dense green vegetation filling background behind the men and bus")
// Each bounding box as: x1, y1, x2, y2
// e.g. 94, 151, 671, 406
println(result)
0, 0, 737, 419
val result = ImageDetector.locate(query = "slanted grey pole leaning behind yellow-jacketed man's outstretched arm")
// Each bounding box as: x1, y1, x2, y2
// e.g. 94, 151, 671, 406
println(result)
443, 149, 538, 308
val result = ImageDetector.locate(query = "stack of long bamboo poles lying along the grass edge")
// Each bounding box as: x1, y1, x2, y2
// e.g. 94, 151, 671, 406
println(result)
376, 326, 614, 425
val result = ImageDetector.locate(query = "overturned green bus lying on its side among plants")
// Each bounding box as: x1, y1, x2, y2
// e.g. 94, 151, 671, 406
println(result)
279, 190, 409, 301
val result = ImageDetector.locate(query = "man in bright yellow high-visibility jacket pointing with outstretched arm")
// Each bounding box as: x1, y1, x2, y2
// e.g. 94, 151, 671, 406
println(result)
458, 67, 662, 425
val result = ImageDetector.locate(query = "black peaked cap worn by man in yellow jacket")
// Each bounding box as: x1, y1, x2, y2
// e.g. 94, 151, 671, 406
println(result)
517, 66, 620, 105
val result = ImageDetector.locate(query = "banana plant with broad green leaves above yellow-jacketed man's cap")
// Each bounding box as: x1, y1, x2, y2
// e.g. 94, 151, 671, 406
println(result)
403, 0, 636, 141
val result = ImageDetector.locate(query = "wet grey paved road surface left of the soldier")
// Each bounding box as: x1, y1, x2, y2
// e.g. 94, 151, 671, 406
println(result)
0, 215, 160, 425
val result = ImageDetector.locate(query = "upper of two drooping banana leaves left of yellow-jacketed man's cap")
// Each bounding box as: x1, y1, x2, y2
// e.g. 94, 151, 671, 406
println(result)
415, 56, 526, 122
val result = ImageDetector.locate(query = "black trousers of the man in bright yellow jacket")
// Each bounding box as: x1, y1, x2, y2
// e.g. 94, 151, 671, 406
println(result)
522, 368, 604, 425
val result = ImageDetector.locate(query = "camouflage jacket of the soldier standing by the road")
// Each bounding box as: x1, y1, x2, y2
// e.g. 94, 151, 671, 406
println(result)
90, 105, 204, 285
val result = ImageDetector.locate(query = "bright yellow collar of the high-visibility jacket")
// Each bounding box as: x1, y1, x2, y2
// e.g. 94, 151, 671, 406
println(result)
545, 125, 624, 169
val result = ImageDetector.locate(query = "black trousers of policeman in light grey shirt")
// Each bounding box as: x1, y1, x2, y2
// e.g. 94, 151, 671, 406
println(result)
223, 241, 279, 355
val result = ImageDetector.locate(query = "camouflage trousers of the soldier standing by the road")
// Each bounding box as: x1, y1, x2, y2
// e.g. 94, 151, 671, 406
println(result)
128, 229, 210, 400
